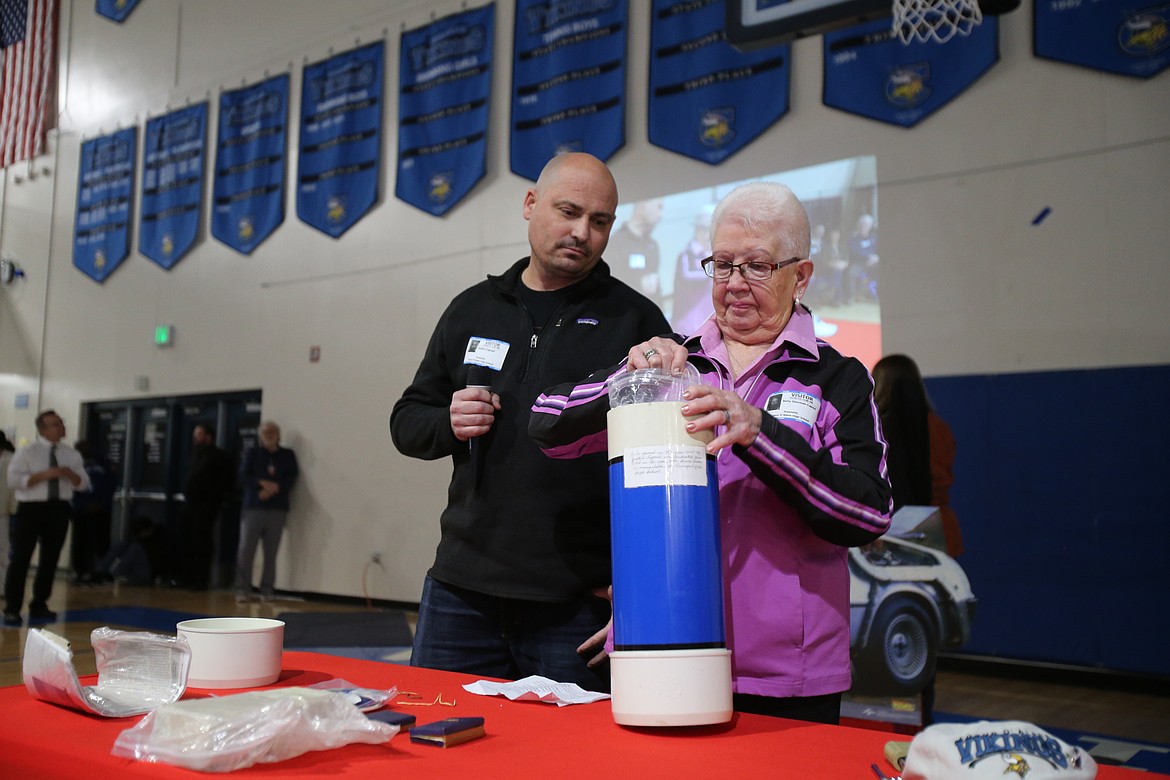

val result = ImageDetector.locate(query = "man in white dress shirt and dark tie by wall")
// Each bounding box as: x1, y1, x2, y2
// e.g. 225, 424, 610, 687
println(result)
4, 409, 89, 626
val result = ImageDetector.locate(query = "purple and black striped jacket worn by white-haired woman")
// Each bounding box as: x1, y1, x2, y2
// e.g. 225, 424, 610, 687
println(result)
529, 306, 892, 697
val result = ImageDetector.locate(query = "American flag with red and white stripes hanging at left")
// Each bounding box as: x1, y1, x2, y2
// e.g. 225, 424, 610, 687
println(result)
0, 0, 57, 167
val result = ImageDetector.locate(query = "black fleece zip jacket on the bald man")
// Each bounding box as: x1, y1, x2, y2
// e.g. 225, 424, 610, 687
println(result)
390, 257, 670, 601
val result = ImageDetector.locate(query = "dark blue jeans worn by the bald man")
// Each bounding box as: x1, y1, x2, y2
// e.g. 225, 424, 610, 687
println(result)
411, 577, 611, 692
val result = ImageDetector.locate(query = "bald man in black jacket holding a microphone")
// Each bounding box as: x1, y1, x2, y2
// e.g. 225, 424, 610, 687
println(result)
390, 153, 669, 690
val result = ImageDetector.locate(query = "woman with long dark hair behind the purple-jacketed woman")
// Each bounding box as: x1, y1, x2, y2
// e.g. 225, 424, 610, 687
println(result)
873, 354, 963, 558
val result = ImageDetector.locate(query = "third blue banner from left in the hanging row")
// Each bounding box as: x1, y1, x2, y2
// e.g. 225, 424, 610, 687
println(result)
212, 74, 289, 255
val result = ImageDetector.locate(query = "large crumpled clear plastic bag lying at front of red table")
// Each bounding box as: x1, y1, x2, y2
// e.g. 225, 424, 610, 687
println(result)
112, 688, 398, 772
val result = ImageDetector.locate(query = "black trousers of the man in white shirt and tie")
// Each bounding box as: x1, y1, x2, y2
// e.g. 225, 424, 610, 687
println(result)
4, 501, 71, 613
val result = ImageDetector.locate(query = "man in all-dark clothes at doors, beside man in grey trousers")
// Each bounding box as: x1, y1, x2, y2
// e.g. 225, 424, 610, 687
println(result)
180, 423, 233, 591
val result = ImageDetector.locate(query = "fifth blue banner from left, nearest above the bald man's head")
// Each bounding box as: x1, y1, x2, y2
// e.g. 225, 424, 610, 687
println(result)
395, 4, 496, 216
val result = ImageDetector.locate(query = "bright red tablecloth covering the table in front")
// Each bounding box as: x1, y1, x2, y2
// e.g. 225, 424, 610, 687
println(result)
0, 653, 1164, 780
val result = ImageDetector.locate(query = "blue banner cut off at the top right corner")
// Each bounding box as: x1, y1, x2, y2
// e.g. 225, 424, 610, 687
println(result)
1032, 0, 1170, 78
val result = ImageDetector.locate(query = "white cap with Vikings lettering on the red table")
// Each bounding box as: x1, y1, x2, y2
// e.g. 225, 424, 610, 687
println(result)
902, 720, 1096, 780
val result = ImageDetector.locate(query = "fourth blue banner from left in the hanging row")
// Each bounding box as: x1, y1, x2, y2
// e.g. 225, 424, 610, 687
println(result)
296, 41, 386, 239
